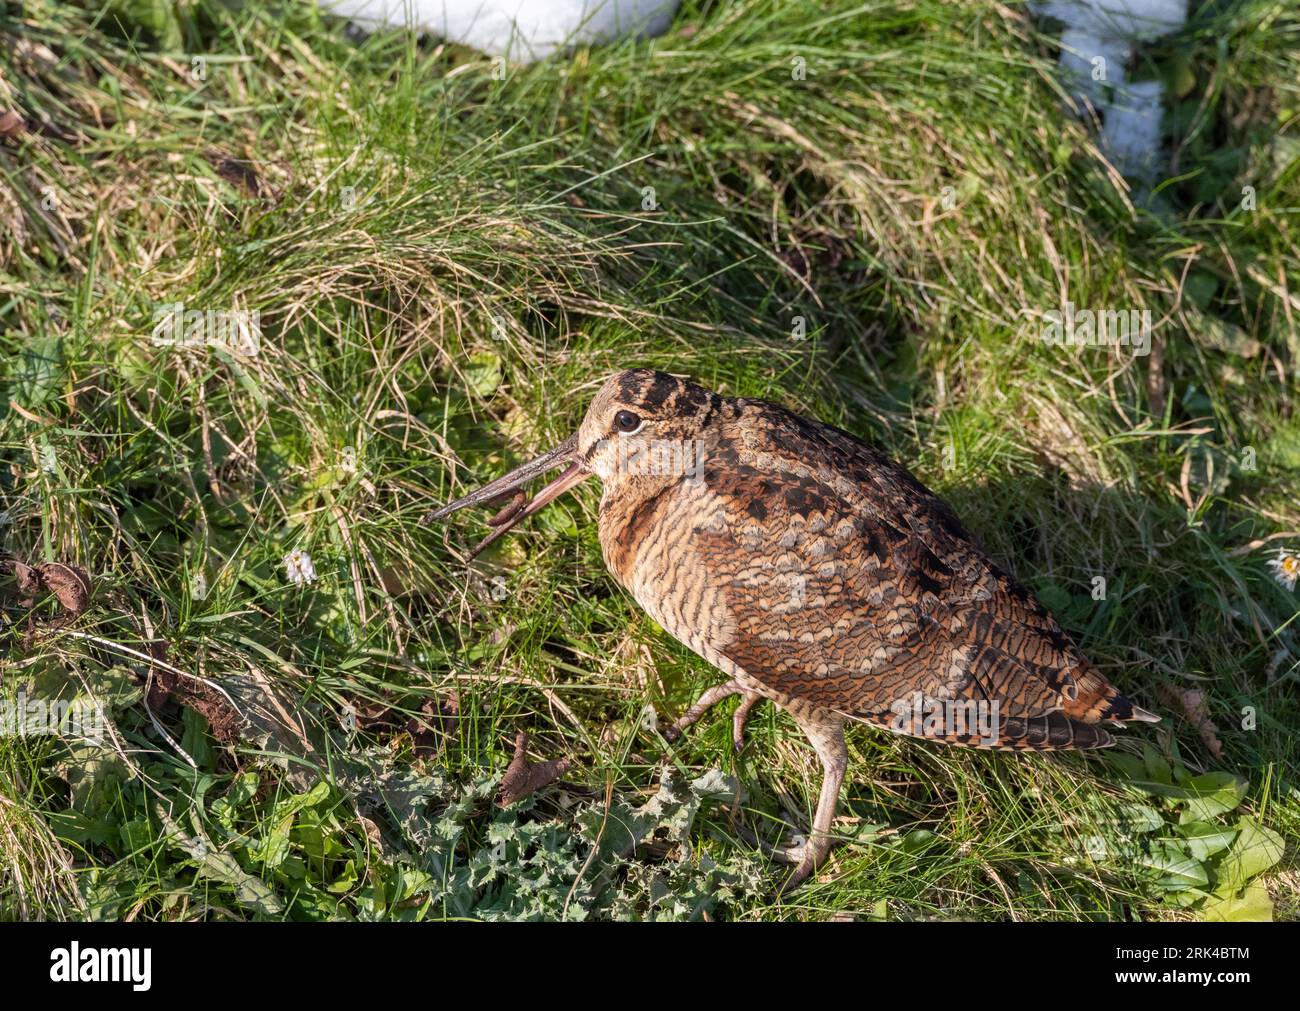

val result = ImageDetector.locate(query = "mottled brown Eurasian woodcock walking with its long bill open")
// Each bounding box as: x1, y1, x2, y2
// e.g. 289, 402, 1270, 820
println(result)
433, 369, 1158, 886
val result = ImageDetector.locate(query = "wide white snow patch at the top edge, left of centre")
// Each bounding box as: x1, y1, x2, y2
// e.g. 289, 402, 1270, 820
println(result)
317, 0, 680, 62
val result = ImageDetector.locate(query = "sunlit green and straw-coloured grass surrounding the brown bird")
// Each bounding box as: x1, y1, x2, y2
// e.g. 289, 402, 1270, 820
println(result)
0, 0, 1300, 920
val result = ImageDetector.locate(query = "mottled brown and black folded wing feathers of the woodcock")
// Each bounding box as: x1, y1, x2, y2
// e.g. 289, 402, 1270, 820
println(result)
690, 402, 1132, 749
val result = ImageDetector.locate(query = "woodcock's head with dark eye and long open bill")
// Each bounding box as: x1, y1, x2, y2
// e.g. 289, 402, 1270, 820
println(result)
430, 369, 722, 555
